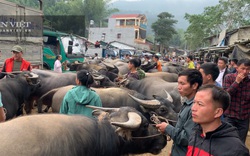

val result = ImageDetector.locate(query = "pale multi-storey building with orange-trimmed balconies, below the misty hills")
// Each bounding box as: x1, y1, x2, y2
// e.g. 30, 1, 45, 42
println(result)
89, 14, 149, 49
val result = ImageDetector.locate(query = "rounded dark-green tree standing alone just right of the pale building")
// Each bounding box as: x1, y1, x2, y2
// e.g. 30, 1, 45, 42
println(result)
151, 12, 177, 51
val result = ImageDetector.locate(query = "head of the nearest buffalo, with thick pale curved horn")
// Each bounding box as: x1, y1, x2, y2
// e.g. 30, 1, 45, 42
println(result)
87, 106, 167, 154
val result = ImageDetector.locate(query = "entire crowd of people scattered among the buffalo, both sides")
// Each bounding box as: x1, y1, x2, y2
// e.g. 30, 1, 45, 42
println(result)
0, 45, 250, 156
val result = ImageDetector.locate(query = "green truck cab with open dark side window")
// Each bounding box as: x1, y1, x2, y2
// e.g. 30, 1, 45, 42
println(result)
43, 29, 85, 71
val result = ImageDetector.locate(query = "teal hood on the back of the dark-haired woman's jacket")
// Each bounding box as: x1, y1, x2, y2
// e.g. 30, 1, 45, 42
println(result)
71, 86, 95, 105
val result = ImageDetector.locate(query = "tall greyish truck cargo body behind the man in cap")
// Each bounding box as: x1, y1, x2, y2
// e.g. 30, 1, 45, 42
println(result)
0, 0, 43, 68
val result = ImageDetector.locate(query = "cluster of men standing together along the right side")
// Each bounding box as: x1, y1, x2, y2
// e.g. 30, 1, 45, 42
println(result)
156, 56, 250, 156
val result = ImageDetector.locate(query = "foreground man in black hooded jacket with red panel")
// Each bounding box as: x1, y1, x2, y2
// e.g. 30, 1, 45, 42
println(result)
187, 85, 249, 156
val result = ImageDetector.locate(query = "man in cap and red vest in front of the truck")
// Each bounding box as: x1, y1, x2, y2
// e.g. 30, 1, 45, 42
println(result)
0, 45, 31, 79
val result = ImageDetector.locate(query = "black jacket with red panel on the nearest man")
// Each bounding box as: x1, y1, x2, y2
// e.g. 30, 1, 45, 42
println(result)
188, 122, 249, 156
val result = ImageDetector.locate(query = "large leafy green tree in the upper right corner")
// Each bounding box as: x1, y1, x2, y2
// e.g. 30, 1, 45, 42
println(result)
185, 0, 250, 49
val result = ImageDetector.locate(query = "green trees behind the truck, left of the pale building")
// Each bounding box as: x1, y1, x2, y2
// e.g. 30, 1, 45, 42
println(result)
5, 0, 118, 36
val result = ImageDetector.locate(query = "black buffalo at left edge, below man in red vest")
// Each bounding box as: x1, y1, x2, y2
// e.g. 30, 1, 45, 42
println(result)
0, 71, 40, 120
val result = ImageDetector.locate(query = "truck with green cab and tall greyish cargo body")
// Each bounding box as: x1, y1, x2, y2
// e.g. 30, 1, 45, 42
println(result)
0, 0, 85, 71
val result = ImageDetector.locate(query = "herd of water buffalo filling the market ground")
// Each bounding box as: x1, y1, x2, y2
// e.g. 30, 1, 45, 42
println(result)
0, 60, 186, 156
